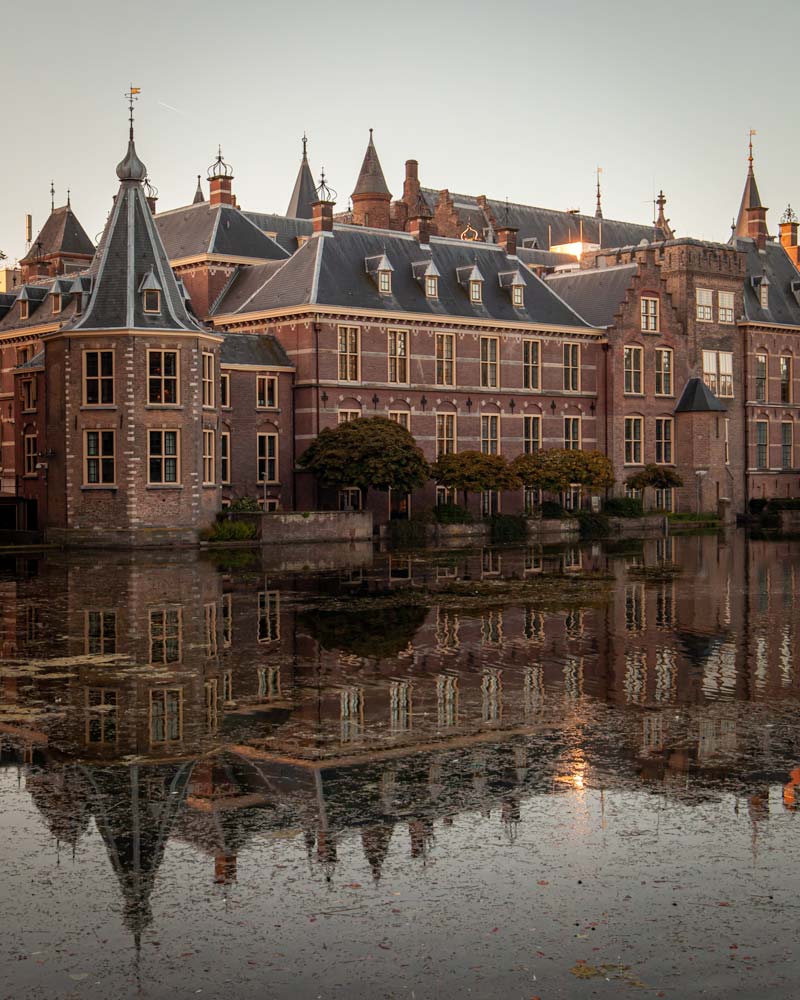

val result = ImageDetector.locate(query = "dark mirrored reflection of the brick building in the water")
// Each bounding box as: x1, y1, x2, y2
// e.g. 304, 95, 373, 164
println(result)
0, 533, 800, 939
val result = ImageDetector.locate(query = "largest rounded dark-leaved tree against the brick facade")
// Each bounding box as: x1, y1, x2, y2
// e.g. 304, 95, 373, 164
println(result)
297, 417, 430, 501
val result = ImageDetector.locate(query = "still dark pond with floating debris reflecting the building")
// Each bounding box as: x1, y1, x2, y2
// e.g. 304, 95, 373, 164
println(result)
0, 530, 800, 1000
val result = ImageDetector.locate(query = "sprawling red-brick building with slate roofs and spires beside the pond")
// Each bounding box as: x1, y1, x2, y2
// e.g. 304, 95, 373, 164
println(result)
0, 125, 800, 544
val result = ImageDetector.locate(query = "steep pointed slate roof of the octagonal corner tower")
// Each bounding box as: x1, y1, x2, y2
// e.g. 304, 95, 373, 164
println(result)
63, 139, 204, 333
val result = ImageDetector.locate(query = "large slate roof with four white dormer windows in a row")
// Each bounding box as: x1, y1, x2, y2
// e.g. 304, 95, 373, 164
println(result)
217, 225, 589, 330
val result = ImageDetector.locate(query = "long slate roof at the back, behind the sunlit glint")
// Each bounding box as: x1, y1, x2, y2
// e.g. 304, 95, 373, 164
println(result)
423, 188, 665, 250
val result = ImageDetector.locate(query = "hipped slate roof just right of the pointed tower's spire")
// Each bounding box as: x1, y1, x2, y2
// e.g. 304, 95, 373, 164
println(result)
155, 201, 288, 260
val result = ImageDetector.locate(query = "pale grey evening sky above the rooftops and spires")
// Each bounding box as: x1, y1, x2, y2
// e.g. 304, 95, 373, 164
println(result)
0, 0, 800, 263
